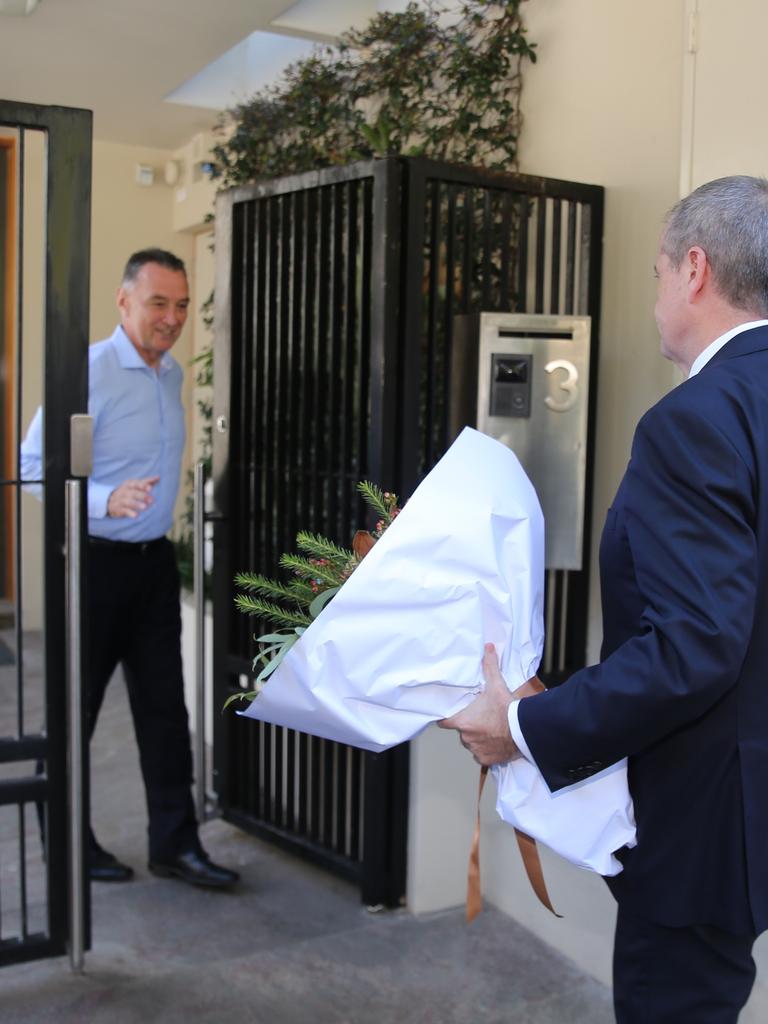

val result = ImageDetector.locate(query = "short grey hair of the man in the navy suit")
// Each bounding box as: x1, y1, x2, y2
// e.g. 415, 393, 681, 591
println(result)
662, 174, 768, 316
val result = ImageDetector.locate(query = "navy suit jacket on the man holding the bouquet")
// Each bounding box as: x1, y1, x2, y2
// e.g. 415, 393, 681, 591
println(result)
519, 327, 768, 933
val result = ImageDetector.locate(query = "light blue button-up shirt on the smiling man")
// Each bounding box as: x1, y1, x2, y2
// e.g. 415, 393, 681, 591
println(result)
22, 327, 184, 543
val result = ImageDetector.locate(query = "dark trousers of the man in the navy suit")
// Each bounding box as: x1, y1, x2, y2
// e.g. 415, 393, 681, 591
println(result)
613, 903, 755, 1024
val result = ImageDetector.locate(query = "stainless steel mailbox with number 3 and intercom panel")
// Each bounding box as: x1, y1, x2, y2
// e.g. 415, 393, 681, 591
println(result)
451, 313, 591, 569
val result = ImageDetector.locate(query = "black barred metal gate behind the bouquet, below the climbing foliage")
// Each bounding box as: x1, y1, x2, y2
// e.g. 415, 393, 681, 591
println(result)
212, 158, 602, 905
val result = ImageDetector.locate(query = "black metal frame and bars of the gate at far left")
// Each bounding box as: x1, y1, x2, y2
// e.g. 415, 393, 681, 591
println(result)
0, 100, 92, 966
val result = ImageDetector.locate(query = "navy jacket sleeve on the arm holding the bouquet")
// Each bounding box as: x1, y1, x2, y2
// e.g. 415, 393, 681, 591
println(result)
519, 386, 757, 790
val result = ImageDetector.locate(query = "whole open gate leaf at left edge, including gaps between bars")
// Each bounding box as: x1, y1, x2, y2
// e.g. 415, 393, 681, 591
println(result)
0, 100, 91, 966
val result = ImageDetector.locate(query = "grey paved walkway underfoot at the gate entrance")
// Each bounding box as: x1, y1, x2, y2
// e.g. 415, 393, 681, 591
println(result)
0, 667, 613, 1024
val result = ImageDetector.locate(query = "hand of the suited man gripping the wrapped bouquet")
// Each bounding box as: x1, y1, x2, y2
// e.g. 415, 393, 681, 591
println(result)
437, 643, 544, 765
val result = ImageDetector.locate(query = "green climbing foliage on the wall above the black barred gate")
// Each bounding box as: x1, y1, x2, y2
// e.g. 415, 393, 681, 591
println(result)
214, 0, 536, 186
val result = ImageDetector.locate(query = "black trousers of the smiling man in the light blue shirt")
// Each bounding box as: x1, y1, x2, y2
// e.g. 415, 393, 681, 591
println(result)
88, 538, 199, 861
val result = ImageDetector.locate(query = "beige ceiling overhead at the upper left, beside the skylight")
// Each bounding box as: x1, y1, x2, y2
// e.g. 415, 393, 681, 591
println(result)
0, 0, 370, 150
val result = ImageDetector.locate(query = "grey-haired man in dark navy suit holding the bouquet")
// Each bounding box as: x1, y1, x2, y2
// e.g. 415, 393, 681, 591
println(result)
443, 176, 768, 1024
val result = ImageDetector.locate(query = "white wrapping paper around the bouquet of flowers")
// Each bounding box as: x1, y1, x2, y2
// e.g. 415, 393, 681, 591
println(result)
243, 428, 634, 874
